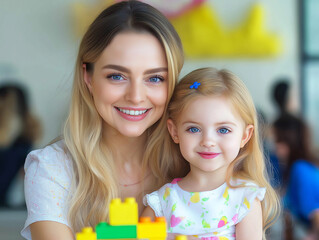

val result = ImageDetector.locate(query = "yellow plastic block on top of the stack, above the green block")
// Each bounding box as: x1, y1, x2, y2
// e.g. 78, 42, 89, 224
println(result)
109, 198, 138, 226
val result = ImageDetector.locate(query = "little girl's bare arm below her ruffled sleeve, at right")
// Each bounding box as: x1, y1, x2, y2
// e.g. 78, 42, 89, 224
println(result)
236, 199, 263, 240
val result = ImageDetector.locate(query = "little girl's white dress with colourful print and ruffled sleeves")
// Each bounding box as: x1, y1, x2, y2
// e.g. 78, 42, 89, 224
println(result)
143, 179, 266, 240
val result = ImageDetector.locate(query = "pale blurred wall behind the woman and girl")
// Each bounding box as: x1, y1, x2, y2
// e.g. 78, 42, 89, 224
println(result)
0, 0, 299, 145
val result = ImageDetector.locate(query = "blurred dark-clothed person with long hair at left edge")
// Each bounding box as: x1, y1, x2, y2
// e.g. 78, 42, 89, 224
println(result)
0, 84, 41, 206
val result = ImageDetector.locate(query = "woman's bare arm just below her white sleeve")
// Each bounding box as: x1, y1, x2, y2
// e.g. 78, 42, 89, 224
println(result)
30, 221, 75, 240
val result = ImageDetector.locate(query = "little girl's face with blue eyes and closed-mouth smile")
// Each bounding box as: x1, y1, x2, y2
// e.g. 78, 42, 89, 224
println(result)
168, 96, 253, 176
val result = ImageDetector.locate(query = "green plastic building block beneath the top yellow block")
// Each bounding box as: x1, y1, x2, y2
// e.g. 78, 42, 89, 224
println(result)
95, 222, 136, 239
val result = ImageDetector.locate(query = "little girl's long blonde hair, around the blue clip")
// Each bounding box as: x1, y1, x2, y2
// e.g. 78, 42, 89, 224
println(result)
168, 68, 280, 237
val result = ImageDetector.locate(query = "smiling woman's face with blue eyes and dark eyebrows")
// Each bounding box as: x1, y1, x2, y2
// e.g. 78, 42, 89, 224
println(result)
84, 32, 168, 137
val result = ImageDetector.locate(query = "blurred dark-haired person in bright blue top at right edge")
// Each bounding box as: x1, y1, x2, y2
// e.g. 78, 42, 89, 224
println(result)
273, 114, 319, 240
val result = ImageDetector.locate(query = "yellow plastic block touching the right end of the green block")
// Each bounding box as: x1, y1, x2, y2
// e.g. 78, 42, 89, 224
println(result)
137, 217, 167, 240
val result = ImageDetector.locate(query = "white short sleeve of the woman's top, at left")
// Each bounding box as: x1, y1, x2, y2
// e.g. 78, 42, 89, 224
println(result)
21, 140, 73, 239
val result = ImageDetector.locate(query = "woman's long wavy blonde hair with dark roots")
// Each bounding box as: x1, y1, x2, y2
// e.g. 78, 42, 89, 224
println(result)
64, 1, 184, 231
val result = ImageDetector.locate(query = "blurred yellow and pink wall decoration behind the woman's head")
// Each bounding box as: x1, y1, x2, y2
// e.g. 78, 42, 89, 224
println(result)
73, 0, 282, 58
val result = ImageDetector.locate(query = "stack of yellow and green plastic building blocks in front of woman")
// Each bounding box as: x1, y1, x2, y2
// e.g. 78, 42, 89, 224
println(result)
76, 198, 167, 240
